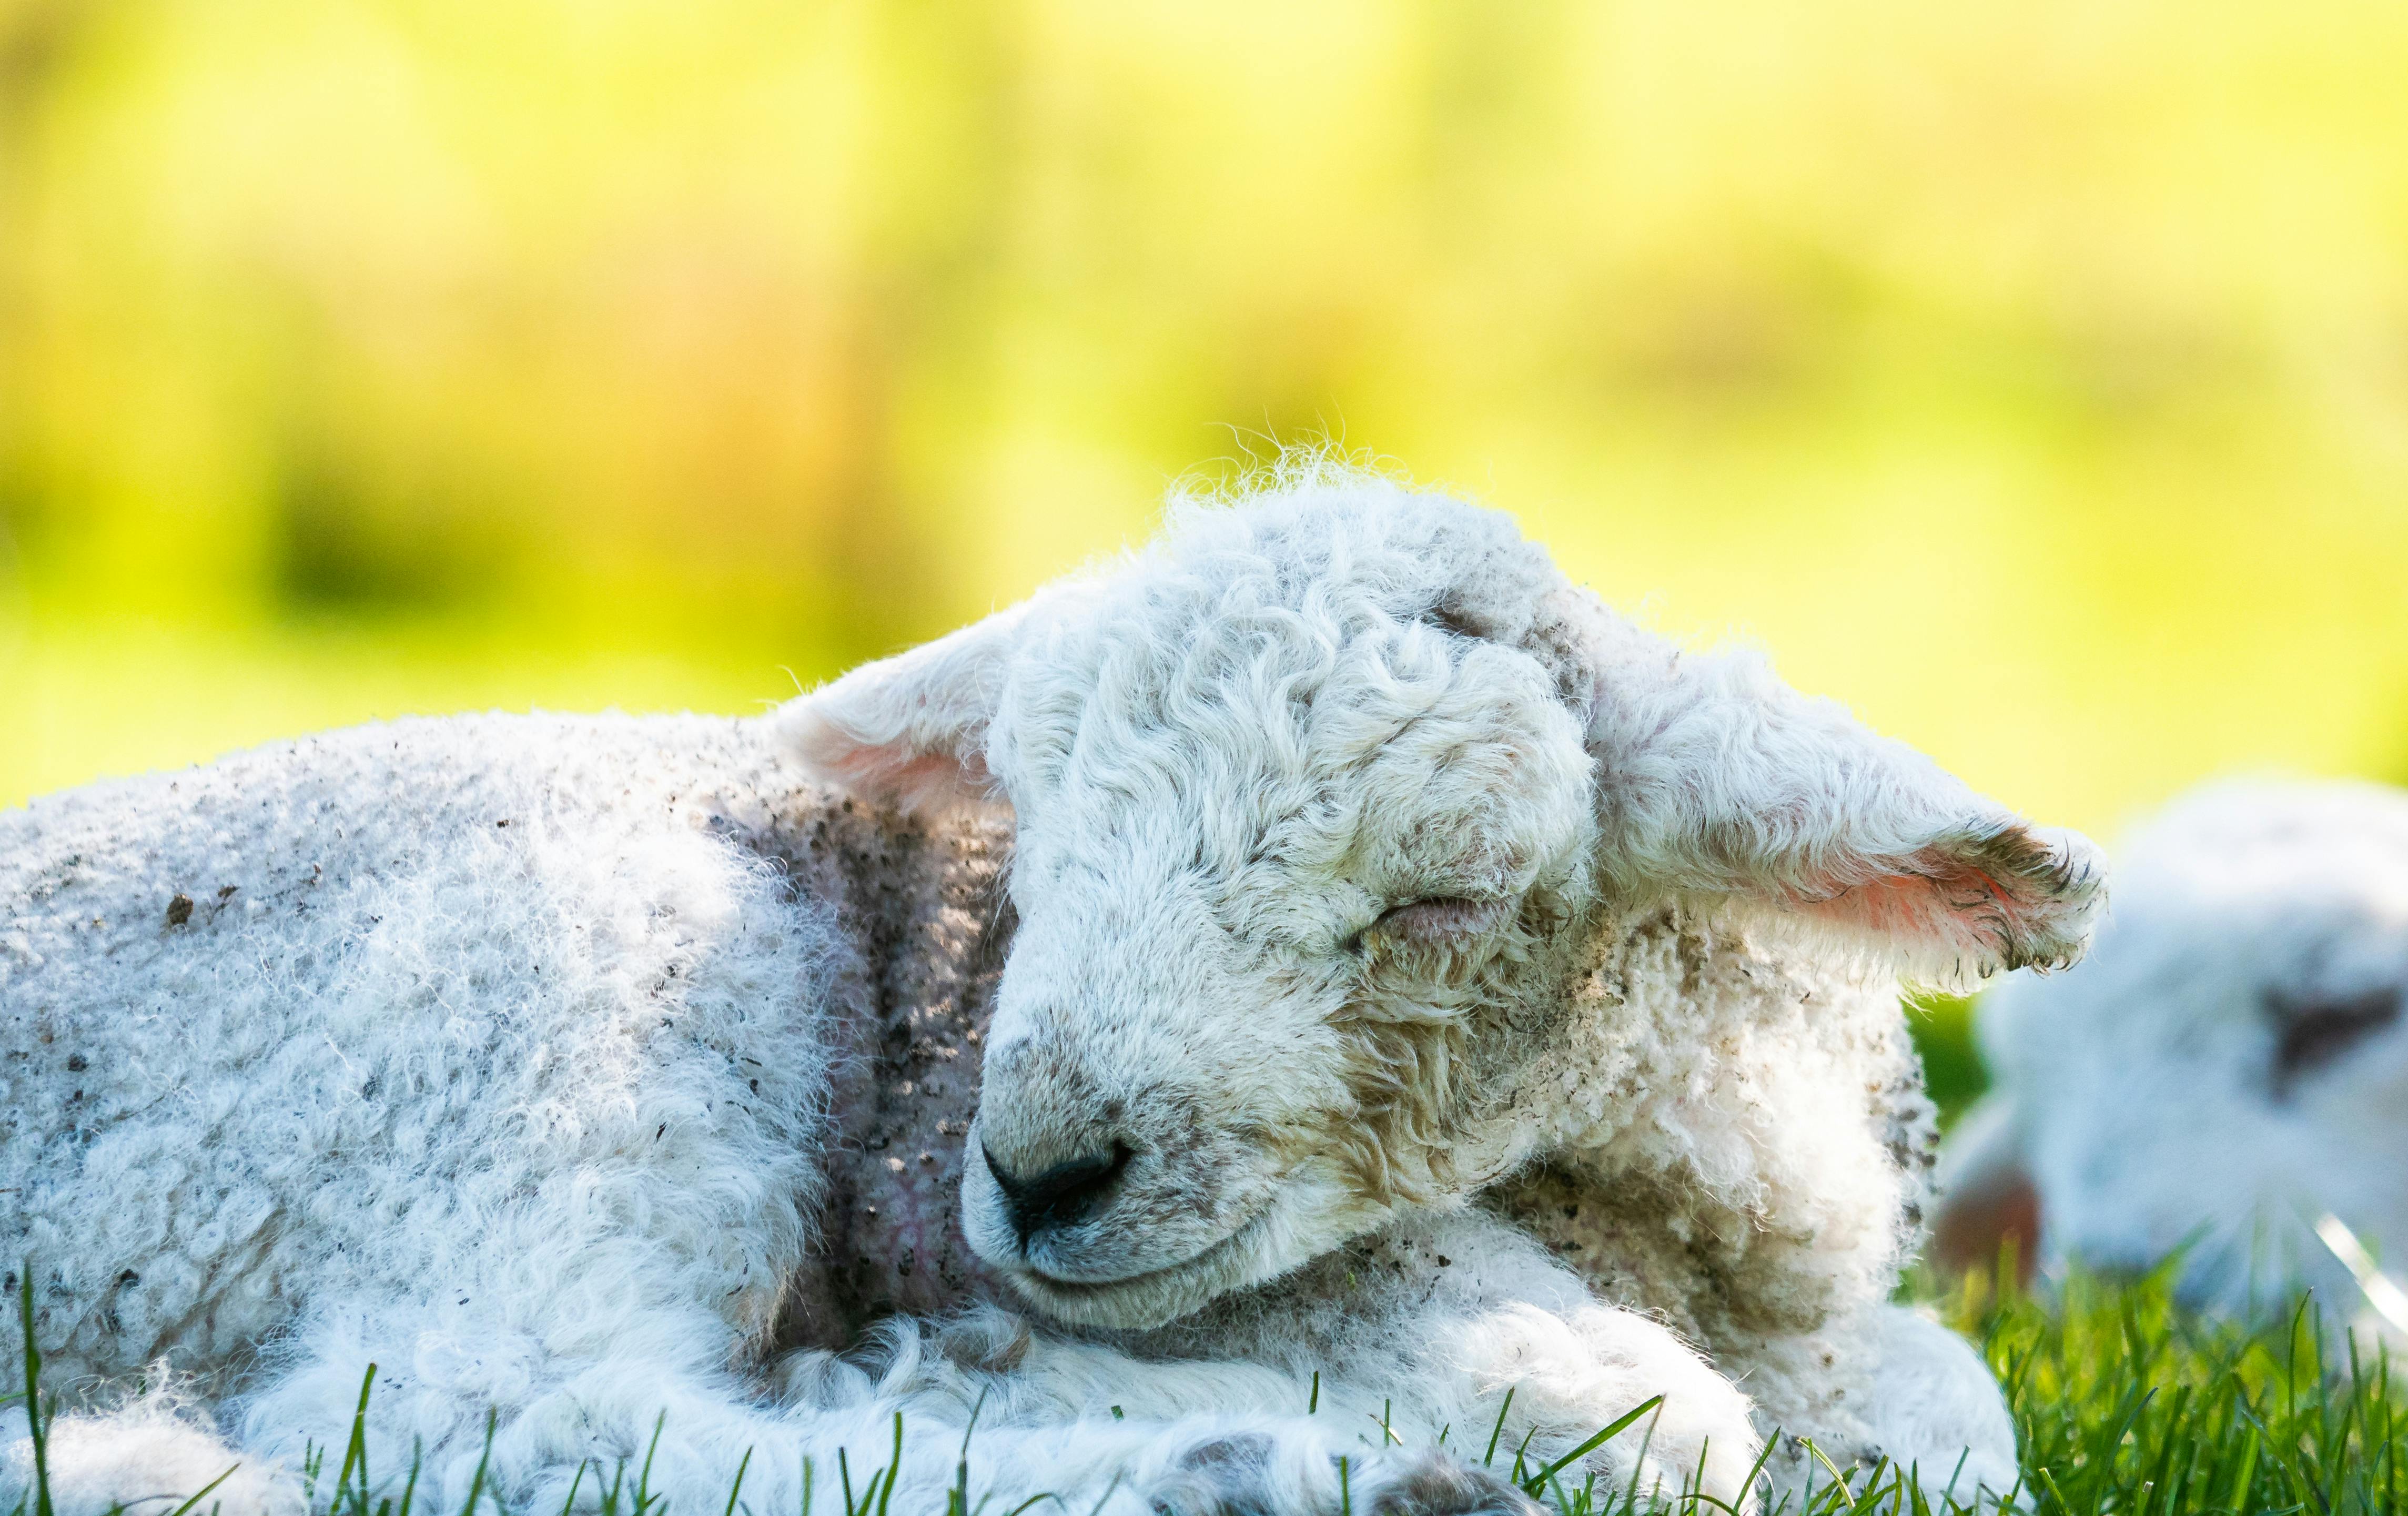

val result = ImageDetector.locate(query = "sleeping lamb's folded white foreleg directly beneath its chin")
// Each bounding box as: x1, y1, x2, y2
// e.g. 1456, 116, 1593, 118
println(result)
987, 1210, 1758, 1504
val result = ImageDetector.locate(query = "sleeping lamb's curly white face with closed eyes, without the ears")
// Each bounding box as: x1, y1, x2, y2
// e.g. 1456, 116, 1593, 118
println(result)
963, 575, 1596, 1323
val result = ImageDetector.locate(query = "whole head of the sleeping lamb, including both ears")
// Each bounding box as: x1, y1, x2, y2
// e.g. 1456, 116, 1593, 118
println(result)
783, 477, 2095, 1326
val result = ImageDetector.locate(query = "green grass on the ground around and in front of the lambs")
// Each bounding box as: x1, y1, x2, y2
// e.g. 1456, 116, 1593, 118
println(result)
7, 1270, 2408, 1516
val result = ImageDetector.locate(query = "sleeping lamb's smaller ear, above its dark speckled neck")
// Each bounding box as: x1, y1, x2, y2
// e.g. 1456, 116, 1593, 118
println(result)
775, 604, 1028, 811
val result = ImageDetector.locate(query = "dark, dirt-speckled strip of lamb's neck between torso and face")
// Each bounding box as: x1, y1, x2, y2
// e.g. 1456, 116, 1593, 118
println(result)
742, 801, 1014, 1350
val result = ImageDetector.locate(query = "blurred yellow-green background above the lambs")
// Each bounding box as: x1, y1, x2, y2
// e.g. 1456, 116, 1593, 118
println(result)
0, 0, 2408, 1107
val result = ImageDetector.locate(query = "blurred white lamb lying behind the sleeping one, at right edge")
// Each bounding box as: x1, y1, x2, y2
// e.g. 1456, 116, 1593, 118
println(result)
1934, 782, 2408, 1331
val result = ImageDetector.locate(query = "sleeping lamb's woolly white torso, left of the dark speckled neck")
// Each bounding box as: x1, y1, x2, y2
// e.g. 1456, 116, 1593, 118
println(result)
0, 717, 867, 1391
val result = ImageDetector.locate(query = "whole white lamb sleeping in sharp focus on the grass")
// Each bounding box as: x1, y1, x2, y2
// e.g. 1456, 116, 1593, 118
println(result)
0, 472, 2100, 1516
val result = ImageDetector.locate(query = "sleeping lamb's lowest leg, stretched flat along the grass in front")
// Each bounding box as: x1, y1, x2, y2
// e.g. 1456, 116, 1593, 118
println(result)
178, 1311, 1529, 1516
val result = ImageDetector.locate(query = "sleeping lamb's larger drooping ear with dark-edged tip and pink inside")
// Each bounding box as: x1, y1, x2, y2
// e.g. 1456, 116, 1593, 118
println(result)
1589, 628, 2105, 984
